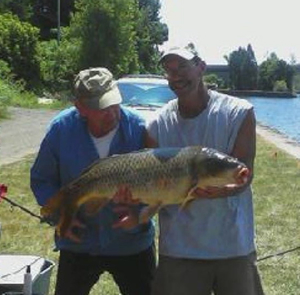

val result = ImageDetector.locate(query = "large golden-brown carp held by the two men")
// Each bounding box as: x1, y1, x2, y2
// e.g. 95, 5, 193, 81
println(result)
41, 146, 249, 236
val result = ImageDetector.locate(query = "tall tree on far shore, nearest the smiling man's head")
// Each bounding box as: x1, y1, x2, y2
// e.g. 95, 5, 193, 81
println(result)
225, 44, 258, 90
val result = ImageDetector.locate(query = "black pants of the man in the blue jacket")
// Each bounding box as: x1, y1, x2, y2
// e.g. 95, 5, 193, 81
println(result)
55, 247, 155, 295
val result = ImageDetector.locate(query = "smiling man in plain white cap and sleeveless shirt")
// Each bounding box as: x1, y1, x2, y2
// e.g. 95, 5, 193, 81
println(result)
148, 48, 263, 295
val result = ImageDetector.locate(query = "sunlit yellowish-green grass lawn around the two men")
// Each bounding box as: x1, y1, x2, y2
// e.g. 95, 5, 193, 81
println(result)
0, 138, 300, 295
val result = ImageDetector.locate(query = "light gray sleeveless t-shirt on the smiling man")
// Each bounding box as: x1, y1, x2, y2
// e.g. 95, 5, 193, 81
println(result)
148, 91, 255, 259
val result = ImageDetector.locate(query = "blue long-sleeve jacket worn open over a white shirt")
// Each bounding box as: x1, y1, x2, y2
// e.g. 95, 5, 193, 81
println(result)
31, 107, 154, 255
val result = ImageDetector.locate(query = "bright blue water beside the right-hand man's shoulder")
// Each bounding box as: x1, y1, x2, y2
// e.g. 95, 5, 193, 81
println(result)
247, 95, 300, 143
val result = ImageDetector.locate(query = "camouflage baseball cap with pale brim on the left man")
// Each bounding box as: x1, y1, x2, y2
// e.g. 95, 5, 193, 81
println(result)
74, 67, 122, 110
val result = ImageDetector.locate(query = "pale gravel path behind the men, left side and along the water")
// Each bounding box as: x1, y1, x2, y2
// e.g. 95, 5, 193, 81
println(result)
0, 108, 300, 166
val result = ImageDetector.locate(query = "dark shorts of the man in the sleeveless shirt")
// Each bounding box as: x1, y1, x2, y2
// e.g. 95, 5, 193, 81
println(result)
152, 253, 263, 295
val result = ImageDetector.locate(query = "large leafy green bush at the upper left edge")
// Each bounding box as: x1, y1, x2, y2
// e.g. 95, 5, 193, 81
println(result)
0, 13, 39, 87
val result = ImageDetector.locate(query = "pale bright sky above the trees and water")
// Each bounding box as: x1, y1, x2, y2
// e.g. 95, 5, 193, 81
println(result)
160, 0, 300, 64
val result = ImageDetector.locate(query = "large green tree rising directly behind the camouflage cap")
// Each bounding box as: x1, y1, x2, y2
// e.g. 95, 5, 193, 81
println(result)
70, 0, 138, 76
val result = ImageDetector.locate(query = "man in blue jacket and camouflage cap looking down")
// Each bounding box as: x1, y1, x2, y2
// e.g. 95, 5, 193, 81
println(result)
31, 68, 155, 295
